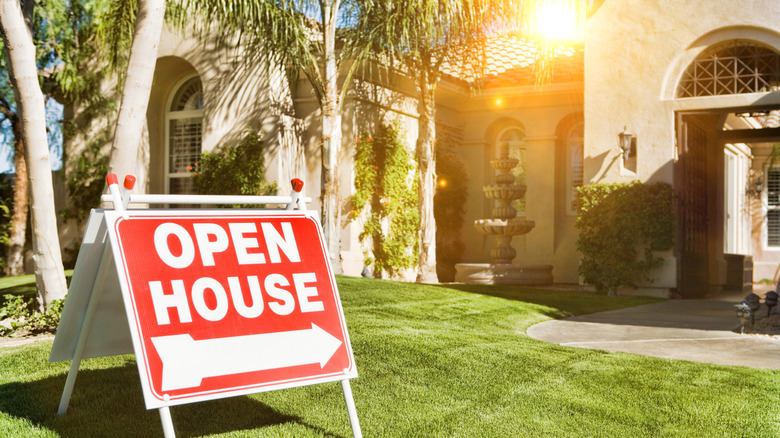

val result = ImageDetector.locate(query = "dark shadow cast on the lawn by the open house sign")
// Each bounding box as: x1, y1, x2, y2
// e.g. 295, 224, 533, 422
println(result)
0, 362, 336, 438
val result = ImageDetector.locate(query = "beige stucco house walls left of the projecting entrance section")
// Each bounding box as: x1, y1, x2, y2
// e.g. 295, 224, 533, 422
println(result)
65, 25, 582, 283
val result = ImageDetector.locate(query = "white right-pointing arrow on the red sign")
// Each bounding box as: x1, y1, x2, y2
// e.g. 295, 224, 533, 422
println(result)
152, 324, 343, 391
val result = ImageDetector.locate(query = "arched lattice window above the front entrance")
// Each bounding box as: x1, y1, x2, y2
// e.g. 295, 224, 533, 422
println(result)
677, 40, 780, 97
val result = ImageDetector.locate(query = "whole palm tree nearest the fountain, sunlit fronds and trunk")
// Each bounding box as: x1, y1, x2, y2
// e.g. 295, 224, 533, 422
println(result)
356, 0, 588, 283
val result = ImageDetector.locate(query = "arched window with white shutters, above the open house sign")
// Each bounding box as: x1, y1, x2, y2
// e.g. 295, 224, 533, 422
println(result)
165, 76, 203, 194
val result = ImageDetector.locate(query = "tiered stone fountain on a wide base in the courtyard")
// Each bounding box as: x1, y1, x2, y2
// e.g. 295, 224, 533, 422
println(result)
455, 139, 553, 285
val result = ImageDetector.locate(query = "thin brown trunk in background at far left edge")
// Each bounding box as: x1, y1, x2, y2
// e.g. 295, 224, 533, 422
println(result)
5, 130, 29, 275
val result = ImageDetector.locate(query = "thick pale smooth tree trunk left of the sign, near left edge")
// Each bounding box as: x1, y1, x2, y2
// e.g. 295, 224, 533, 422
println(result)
0, 0, 67, 309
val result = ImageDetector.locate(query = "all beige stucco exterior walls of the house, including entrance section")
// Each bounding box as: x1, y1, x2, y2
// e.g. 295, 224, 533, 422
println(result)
61, 0, 780, 294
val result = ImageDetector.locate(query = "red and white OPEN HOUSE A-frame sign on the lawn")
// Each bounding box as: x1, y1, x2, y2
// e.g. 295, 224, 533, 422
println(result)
49, 175, 362, 438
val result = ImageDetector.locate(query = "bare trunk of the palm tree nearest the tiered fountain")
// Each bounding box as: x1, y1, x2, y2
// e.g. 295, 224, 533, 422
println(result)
417, 69, 438, 283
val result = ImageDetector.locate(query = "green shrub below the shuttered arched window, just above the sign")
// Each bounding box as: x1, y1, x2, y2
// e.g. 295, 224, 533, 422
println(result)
188, 130, 277, 204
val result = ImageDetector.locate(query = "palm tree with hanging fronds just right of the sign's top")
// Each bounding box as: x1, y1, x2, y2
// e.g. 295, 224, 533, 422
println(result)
181, 0, 374, 273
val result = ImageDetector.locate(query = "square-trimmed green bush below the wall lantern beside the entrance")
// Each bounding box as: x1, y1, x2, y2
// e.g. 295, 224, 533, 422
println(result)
577, 181, 674, 295
